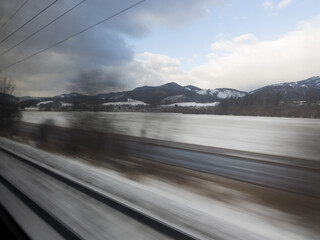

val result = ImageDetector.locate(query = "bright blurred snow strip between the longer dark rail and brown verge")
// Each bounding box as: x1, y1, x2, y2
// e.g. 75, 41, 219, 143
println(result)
0, 138, 319, 240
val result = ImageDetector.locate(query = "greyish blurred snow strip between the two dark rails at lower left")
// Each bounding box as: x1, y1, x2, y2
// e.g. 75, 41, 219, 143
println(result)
0, 153, 168, 240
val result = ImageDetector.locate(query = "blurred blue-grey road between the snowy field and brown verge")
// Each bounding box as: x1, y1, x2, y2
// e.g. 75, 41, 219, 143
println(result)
128, 142, 320, 198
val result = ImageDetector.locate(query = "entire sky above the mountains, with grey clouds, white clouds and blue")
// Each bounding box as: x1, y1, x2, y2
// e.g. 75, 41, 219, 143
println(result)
0, 0, 320, 96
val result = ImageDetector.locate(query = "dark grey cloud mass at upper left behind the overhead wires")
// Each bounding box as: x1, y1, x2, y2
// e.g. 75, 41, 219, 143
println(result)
0, 0, 216, 96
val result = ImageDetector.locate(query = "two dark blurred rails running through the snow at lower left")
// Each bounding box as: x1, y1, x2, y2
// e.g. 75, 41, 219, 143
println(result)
0, 147, 198, 240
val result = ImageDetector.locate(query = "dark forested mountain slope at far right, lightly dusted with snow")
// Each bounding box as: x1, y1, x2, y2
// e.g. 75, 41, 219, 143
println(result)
214, 77, 320, 118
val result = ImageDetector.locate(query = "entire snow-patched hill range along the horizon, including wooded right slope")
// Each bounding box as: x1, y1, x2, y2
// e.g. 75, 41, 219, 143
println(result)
16, 77, 320, 117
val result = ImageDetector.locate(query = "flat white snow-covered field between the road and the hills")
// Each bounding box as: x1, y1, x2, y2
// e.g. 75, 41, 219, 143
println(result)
22, 112, 320, 160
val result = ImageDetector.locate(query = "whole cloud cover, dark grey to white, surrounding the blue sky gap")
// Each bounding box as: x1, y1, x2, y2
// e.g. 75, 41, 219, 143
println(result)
0, 0, 320, 96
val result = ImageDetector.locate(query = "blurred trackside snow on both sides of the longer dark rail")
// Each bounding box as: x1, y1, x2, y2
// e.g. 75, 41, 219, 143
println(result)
0, 138, 319, 240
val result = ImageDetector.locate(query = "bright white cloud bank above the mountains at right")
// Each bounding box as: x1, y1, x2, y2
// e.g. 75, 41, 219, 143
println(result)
113, 15, 320, 91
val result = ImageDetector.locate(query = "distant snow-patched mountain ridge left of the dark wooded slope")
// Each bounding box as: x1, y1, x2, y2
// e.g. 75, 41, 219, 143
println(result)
16, 82, 246, 107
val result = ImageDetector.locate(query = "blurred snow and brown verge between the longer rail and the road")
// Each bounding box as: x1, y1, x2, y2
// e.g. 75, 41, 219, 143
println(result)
1, 135, 320, 239
